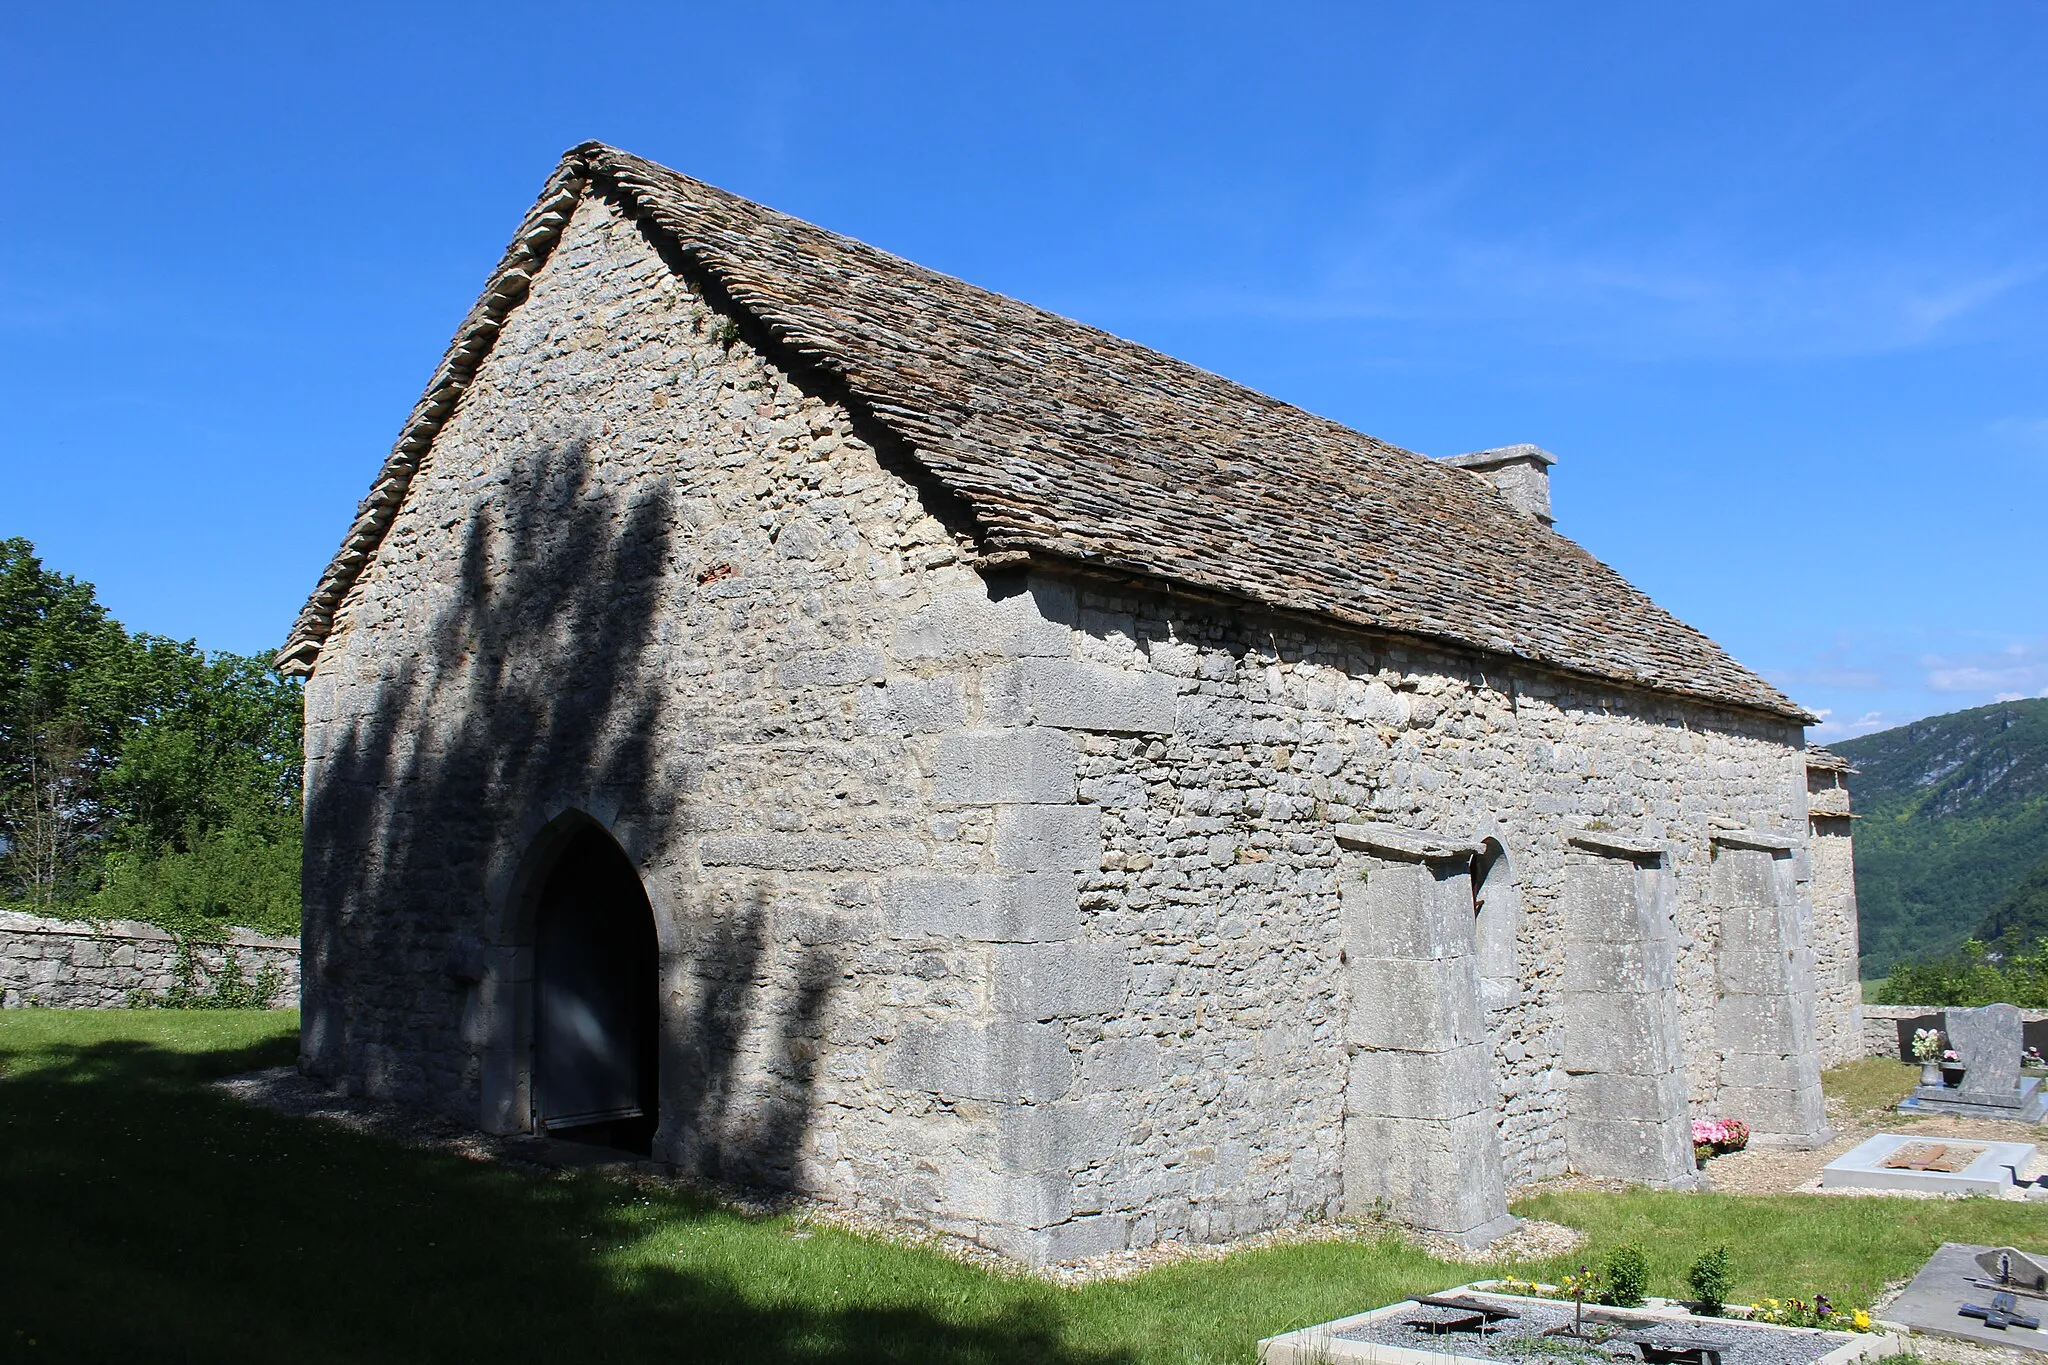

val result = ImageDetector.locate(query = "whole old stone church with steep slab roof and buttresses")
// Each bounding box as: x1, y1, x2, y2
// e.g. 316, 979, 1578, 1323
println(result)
279, 143, 1860, 1263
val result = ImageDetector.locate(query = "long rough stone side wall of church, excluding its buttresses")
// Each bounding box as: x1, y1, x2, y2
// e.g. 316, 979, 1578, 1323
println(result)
1015, 577, 1804, 1236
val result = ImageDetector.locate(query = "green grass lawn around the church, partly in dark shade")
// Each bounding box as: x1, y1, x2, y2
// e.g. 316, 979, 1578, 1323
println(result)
0, 1011, 2048, 1363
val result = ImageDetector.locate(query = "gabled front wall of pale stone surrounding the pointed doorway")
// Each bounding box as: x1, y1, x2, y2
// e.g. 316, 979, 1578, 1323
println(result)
303, 187, 1100, 1236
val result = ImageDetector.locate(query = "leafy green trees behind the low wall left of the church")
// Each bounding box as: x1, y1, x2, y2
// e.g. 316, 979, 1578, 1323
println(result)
0, 538, 301, 933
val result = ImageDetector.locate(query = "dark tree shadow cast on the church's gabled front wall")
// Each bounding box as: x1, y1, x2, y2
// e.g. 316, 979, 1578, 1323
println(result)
305, 438, 838, 1187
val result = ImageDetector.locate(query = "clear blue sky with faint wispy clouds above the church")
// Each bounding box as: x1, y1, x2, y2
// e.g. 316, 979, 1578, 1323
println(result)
0, 2, 2048, 737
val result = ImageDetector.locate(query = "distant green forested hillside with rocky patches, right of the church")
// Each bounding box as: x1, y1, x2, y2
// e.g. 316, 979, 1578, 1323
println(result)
1831, 698, 2048, 978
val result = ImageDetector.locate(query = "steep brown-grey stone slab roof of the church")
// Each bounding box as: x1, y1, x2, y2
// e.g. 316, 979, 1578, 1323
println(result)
279, 143, 1812, 722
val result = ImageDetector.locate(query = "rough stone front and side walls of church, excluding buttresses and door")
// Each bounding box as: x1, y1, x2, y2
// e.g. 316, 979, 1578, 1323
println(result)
305, 184, 1835, 1259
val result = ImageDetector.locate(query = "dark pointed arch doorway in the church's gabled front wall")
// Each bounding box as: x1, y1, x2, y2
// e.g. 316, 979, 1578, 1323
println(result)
532, 825, 662, 1156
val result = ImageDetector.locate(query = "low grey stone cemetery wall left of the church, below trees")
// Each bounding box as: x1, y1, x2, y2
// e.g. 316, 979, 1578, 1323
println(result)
0, 911, 299, 1009
